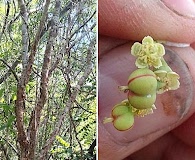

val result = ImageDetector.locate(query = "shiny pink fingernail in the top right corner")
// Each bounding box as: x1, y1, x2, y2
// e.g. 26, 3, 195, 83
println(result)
162, 0, 195, 17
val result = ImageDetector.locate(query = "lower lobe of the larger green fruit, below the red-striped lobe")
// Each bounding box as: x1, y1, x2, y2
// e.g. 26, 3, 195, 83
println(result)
128, 92, 156, 109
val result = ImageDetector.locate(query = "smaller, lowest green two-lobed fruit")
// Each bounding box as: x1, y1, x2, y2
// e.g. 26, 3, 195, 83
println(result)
112, 105, 134, 131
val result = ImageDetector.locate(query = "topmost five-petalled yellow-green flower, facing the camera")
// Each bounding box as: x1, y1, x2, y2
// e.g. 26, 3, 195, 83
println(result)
131, 36, 165, 68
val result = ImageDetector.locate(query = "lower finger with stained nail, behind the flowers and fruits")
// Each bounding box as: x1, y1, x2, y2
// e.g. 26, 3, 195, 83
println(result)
98, 44, 195, 160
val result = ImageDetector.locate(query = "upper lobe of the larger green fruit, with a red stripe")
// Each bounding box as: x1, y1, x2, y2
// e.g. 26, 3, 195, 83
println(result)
128, 68, 157, 95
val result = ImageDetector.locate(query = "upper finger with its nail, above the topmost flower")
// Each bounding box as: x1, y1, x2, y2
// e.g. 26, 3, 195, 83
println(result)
98, 0, 195, 43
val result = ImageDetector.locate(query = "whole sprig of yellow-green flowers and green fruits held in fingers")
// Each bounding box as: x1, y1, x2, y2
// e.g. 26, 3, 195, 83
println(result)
104, 36, 180, 131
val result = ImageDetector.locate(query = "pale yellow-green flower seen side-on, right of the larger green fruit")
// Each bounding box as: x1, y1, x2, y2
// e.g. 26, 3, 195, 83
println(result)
154, 70, 180, 94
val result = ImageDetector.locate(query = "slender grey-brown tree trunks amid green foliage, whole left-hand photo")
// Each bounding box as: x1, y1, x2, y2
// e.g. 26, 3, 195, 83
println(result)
0, 0, 97, 160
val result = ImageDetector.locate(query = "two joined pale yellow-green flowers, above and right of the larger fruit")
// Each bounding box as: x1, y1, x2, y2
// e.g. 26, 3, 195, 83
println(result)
131, 36, 180, 94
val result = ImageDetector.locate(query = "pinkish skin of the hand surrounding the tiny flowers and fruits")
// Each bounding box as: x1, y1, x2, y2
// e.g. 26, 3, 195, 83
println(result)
98, 0, 195, 160
